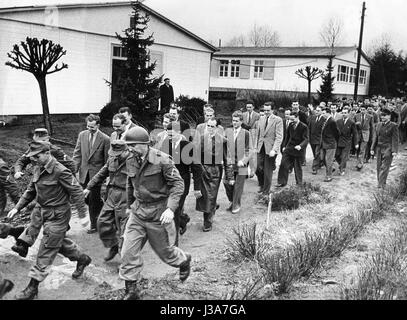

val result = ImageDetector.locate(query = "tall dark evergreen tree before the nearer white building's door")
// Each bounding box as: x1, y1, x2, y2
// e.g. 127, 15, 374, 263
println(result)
114, 1, 162, 129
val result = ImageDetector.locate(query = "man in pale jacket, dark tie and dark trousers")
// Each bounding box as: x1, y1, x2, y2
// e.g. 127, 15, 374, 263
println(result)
256, 102, 284, 195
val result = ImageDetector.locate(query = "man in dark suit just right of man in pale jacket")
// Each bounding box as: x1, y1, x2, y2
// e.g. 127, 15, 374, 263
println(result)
277, 112, 308, 187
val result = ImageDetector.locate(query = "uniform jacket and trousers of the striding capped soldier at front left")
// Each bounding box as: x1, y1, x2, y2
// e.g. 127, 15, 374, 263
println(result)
15, 157, 87, 282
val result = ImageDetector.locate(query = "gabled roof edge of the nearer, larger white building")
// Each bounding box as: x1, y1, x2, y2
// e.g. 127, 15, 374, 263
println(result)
0, 1, 219, 51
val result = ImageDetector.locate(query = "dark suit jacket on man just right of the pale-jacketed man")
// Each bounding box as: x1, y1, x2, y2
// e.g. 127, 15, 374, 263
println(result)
282, 121, 308, 157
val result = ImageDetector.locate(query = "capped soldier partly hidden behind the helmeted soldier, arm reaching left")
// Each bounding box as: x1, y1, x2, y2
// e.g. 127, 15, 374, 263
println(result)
83, 140, 130, 261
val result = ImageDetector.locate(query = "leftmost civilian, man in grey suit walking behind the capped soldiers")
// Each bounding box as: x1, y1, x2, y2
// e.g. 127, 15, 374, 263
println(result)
73, 114, 110, 233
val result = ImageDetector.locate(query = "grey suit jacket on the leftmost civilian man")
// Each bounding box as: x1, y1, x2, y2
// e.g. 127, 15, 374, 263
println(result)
73, 130, 110, 184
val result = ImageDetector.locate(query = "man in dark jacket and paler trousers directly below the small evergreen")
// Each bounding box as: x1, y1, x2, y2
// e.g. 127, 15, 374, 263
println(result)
321, 108, 339, 182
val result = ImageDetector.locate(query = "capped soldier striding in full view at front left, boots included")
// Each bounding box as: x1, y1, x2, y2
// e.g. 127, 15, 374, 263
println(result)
7, 141, 92, 300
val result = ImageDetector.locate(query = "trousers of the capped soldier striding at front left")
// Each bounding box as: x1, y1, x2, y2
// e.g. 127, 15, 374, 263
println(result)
28, 204, 81, 281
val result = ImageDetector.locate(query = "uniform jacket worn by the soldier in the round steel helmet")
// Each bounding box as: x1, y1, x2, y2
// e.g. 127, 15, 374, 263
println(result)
126, 147, 184, 221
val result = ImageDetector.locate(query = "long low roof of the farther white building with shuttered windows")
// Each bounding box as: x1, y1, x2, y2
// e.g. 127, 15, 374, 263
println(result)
214, 46, 370, 63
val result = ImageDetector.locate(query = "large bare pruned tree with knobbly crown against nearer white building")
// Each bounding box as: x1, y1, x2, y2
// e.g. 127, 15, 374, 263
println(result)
6, 37, 68, 134
